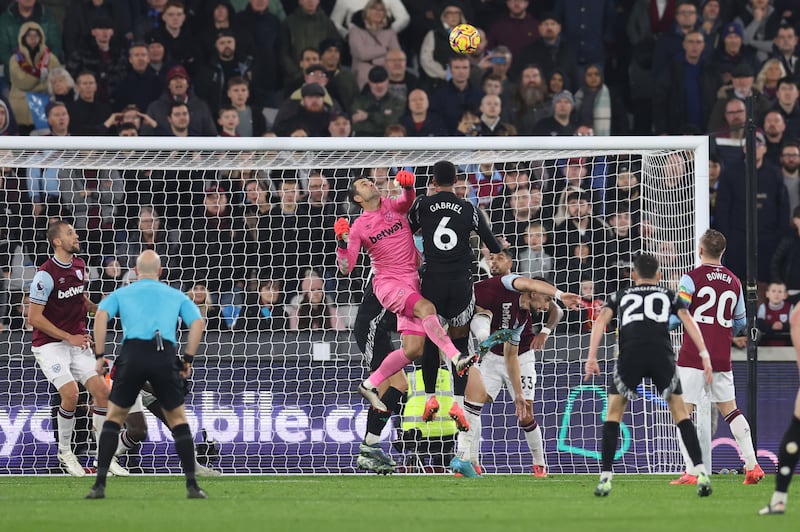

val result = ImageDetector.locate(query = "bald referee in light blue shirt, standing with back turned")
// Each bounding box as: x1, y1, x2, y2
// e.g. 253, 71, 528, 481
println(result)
86, 250, 207, 499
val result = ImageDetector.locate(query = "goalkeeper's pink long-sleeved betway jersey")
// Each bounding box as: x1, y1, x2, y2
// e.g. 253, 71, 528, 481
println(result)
336, 188, 421, 283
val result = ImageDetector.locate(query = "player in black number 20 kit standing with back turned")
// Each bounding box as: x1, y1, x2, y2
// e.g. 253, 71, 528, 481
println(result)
584, 254, 713, 497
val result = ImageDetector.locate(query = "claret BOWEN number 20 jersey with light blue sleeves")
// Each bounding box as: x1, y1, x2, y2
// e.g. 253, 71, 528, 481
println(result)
678, 264, 745, 371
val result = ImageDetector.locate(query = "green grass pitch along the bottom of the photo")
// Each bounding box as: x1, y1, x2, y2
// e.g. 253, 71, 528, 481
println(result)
0, 475, 800, 532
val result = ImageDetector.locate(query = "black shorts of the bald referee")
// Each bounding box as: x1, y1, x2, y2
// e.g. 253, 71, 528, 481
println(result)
108, 340, 184, 410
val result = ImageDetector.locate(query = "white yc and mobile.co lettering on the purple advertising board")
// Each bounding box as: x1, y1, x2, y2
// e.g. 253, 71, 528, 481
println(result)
0, 391, 393, 458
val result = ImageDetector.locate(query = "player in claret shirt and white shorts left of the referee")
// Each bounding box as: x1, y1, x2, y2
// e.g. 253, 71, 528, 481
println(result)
28, 220, 128, 477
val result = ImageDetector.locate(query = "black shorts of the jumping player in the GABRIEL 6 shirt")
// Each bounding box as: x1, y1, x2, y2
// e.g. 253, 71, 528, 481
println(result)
421, 271, 475, 327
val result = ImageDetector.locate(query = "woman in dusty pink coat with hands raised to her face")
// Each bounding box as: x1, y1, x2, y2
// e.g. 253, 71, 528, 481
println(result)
347, 0, 400, 88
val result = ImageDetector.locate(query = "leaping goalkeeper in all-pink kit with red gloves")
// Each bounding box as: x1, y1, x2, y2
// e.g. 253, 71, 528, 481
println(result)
334, 170, 476, 411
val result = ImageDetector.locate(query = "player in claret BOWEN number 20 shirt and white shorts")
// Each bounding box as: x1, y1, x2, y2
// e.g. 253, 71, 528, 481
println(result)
671, 229, 764, 484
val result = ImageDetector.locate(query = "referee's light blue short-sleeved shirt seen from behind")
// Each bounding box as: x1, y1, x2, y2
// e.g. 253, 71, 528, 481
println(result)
98, 279, 202, 345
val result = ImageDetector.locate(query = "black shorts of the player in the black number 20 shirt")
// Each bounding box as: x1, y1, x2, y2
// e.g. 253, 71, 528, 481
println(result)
608, 346, 683, 399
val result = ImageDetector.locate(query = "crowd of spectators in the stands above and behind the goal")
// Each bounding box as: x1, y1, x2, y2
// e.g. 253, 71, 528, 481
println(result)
0, 0, 800, 344
